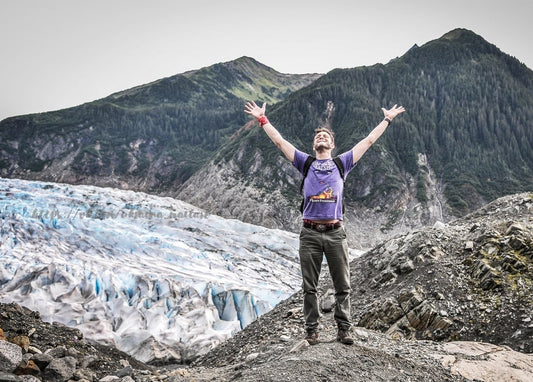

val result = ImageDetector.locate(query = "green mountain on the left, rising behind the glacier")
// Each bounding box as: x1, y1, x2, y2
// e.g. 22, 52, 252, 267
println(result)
0, 57, 320, 192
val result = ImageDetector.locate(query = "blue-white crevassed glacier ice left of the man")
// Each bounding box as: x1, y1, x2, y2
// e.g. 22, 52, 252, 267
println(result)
0, 178, 301, 363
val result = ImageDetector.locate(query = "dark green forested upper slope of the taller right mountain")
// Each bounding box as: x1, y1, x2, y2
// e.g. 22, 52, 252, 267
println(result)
209, 29, 533, 215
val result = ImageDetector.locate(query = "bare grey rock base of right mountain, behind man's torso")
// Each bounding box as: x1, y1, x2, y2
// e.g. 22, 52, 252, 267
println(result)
178, 153, 450, 249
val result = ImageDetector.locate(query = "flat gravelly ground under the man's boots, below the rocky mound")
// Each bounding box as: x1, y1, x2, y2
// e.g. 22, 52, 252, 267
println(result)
190, 291, 533, 382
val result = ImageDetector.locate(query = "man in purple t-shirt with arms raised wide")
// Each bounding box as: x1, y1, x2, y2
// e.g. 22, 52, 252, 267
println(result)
244, 101, 405, 345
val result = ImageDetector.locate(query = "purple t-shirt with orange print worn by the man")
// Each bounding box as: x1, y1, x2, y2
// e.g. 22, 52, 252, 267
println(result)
292, 150, 354, 220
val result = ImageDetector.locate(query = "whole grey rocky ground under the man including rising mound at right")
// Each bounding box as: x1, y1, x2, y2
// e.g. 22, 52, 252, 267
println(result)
190, 194, 533, 382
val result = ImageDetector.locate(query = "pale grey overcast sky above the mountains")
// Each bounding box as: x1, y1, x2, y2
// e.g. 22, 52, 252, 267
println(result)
0, 0, 533, 120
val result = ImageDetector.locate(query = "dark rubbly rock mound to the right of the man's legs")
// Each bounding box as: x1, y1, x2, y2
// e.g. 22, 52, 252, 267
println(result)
351, 194, 533, 353
